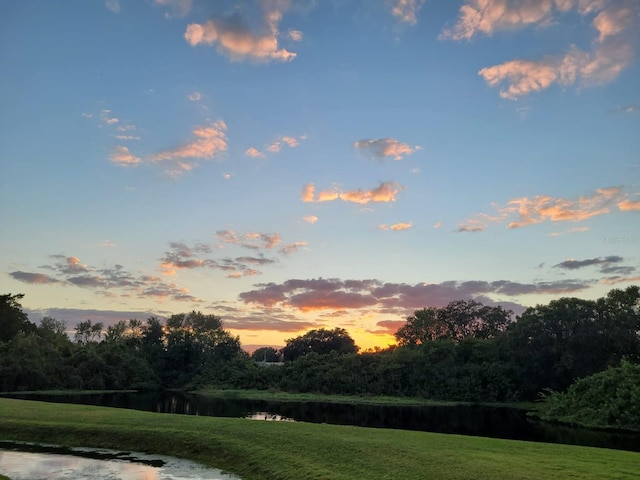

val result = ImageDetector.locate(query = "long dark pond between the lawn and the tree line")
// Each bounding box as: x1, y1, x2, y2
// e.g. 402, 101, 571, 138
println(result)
8, 392, 640, 452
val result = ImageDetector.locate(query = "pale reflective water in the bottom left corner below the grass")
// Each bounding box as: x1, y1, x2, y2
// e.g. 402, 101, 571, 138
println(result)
0, 441, 239, 480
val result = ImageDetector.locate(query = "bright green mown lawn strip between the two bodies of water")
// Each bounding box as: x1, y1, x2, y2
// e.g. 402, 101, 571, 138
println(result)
0, 398, 640, 480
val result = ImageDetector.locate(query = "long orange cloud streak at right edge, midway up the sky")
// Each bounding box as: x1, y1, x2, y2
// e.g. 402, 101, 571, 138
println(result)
458, 187, 635, 232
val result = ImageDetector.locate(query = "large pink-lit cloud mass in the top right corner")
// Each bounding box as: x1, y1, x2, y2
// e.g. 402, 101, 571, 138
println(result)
476, 0, 640, 100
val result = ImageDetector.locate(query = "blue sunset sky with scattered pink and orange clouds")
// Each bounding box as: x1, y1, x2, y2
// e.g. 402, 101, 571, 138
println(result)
0, 0, 640, 350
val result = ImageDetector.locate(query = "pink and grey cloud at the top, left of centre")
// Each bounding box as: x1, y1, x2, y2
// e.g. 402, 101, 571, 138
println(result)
184, 1, 296, 62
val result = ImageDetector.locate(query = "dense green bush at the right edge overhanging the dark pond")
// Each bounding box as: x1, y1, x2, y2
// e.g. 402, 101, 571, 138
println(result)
536, 360, 640, 431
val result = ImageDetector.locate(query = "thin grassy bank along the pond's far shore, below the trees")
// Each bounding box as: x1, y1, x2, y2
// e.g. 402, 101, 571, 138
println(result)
193, 388, 535, 410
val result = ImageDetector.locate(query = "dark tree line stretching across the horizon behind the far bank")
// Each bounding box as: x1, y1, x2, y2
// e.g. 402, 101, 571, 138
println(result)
0, 286, 640, 401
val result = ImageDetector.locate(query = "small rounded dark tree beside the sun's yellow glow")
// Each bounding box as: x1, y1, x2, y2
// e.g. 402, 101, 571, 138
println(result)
282, 327, 358, 361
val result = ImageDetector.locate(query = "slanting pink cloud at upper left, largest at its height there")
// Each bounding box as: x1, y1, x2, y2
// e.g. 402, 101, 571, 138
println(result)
150, 120, 228, 177
